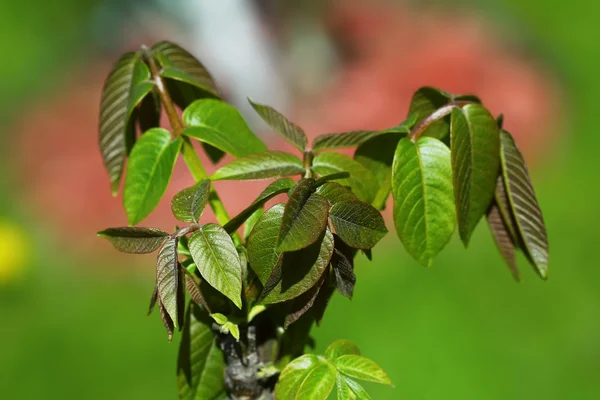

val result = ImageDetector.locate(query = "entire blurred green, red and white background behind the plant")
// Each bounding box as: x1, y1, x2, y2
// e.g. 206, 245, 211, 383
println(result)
0, 0, 600, 400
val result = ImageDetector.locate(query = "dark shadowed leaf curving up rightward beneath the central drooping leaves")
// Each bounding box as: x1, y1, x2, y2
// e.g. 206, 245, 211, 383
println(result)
257, 227, 334, 304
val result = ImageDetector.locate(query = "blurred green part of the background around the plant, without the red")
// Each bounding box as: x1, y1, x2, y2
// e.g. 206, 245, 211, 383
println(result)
0, 0, 600, 400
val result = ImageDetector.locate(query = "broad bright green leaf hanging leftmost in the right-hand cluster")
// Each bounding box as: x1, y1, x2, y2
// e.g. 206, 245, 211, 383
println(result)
392, 137, 456, 266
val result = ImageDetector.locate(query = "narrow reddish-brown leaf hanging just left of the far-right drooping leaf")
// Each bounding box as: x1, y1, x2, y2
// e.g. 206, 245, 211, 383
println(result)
487, 176, 521, 282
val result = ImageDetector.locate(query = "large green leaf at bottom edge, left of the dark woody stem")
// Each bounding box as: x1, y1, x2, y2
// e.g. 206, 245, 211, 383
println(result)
177, 304, 225, 400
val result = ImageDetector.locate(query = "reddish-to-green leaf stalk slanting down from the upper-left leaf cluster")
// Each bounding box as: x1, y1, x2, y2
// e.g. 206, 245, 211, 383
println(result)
142, 46, 242, 245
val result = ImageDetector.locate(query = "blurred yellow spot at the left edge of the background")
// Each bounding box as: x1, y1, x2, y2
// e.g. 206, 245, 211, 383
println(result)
0, 220, 27, 286
